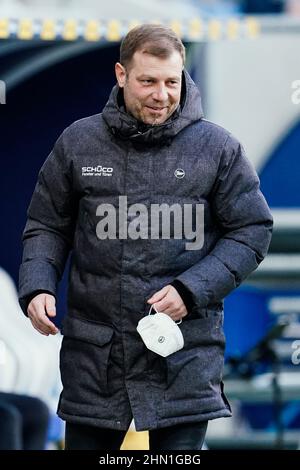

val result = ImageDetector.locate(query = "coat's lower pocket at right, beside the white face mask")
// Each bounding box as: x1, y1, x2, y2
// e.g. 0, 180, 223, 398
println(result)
165, 312, 225, 400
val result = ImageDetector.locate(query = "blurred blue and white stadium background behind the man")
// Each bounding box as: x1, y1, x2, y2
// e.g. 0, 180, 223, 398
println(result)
0, 0, 300, 449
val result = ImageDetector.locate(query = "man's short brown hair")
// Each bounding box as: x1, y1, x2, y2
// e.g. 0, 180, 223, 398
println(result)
120, 24, 185, 69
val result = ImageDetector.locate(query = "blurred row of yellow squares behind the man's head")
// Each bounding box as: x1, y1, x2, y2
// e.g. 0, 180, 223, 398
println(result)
0, 17, 261, 42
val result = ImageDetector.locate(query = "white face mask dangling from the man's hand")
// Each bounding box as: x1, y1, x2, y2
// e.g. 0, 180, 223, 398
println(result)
137, 305, 184, 357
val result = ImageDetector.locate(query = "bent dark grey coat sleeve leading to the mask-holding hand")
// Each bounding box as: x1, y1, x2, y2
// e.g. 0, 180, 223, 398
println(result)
176, 138, 273, 308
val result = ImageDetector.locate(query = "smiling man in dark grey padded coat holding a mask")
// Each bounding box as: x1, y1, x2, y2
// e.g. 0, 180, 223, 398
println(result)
20, 25, 272, 450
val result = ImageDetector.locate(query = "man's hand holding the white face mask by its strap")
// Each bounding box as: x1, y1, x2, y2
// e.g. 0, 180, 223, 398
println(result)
147, 284, 188, 321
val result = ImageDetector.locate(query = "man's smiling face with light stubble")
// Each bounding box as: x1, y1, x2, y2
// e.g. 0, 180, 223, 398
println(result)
116, 51, 183, 125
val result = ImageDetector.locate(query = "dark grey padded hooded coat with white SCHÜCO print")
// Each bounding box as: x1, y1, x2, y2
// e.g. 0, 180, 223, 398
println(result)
20, 73, 272, 430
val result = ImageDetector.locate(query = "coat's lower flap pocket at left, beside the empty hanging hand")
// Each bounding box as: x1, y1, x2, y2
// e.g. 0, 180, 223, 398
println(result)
60, 316, 114, 404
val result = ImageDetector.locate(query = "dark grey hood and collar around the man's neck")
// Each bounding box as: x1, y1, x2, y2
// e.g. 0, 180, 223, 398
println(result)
102, 70, 203, 145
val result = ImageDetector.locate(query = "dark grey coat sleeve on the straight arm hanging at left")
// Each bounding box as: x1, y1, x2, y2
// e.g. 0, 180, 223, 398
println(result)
19, 135, 77, 314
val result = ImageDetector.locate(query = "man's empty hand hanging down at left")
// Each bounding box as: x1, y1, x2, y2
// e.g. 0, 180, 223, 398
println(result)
27, 294, 58, 336
